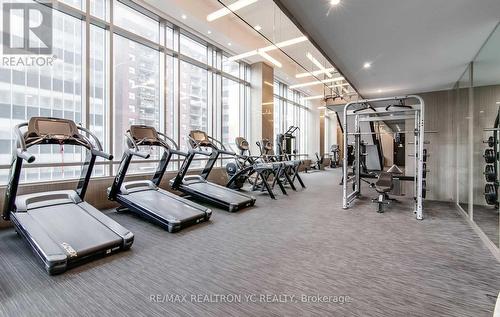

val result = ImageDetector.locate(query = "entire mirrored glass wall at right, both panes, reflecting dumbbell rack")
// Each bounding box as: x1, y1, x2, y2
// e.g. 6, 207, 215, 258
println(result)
455, 22, 500, 247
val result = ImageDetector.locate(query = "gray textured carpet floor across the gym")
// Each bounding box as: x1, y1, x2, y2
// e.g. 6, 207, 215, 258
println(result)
0, 169, 500, 316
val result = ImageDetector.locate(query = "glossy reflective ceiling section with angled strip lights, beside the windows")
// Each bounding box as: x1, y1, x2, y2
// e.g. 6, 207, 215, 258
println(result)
142, 0, 354, 99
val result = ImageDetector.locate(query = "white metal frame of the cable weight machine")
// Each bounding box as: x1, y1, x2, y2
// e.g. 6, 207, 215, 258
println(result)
342, 95, 427, 220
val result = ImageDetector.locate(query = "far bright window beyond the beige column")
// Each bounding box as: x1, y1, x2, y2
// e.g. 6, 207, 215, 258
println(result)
273, 81, 311, 156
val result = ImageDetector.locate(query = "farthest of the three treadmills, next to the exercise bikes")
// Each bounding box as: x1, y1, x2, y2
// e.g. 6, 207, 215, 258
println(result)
170, 130, 255, 212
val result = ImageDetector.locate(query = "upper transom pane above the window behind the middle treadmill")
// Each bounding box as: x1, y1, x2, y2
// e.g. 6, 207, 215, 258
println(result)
113, 1, 160, 42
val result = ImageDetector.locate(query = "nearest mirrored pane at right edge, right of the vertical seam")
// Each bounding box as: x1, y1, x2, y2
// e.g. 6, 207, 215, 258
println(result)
471, 27, 500, 247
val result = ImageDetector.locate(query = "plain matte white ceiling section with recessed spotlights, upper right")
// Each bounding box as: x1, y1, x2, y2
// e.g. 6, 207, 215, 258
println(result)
279, 0, 500, 97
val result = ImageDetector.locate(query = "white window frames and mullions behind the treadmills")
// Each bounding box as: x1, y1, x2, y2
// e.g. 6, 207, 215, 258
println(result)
0, 0, 251, 186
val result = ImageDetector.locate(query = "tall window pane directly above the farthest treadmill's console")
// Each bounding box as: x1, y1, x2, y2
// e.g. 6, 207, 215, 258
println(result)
179, 61, 209, 150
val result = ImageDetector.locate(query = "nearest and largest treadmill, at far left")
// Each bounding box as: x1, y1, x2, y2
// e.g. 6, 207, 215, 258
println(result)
2, 117, 134, 274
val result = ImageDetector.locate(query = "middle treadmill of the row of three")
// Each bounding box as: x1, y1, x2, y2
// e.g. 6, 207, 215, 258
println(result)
108, 125, 212, 232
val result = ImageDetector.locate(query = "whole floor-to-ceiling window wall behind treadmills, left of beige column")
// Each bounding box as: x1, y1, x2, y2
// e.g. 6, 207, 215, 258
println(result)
0, 0, 250, 184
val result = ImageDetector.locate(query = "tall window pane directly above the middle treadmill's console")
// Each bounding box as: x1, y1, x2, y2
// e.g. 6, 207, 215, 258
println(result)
113, 35, 160, 157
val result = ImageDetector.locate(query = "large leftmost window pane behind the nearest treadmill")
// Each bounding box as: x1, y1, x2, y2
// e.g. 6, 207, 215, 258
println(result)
0, 11, 82, 183
